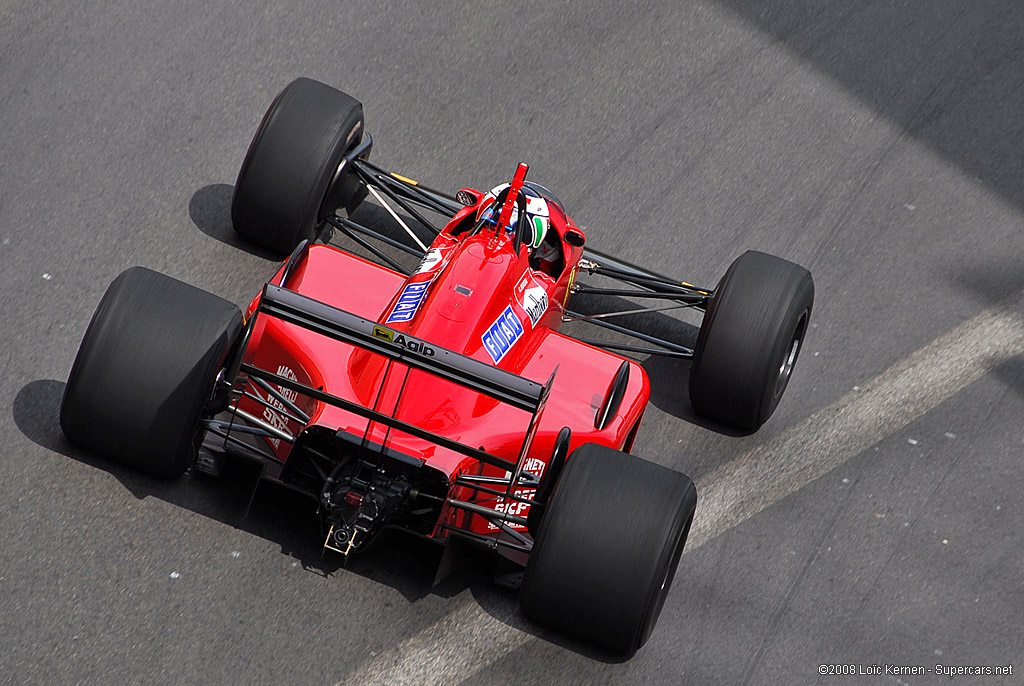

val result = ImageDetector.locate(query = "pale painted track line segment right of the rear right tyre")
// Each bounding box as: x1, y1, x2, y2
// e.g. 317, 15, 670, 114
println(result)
687, 291, 1024, 548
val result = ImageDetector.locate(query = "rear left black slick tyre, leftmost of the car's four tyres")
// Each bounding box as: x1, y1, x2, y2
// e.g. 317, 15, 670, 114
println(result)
60, 267, 242, 478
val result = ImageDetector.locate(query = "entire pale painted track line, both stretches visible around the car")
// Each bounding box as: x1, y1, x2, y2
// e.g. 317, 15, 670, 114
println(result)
336, 291, 1024, 686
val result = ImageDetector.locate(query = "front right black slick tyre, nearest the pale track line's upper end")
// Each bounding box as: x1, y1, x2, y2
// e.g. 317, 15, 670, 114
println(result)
689, 251, 814, 431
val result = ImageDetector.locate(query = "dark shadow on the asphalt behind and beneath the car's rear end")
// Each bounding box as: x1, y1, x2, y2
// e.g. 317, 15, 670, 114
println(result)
13, 379, 493, 602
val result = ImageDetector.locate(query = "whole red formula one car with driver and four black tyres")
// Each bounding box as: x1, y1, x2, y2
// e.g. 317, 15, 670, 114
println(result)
60, 79, 814, 654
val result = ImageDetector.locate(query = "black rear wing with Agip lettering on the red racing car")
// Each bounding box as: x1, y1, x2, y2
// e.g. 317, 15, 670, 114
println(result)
227, 284, 557, 475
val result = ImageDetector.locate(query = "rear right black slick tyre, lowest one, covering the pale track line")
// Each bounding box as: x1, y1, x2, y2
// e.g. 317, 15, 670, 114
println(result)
519, 443, 697, 655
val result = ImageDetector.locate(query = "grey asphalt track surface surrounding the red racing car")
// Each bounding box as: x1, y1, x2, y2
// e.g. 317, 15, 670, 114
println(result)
0, 0, 1024, 686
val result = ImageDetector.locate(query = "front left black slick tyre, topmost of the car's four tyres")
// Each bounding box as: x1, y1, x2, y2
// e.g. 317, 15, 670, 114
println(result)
231, 79, 367, 255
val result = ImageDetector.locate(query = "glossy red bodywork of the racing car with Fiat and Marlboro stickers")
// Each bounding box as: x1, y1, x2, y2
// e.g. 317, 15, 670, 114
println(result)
234, 189, 650, 539
